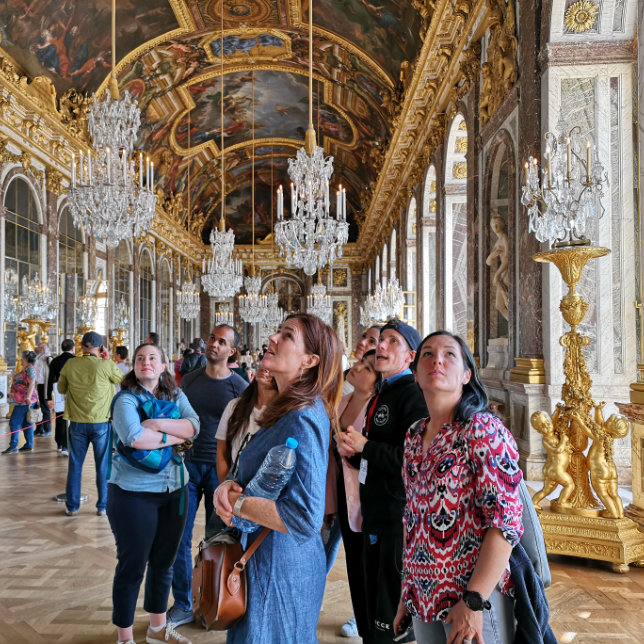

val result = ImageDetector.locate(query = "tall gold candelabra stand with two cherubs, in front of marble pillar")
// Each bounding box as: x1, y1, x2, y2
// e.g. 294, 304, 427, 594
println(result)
531, 245, 644, 572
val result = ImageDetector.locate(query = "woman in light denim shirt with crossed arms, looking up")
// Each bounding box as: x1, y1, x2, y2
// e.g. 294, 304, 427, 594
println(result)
107, 344, 199, 644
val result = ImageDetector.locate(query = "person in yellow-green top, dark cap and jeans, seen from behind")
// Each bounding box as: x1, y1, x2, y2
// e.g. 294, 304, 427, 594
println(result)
58, 331, 123, 517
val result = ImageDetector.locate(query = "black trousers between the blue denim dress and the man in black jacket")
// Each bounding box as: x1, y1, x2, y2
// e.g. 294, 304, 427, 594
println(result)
337, 466, 369, 641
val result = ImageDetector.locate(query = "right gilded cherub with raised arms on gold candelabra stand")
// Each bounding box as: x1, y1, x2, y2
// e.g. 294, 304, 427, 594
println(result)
571, 403, 628, 519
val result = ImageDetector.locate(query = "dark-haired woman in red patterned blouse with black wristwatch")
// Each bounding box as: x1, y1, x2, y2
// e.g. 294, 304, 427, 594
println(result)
394, 331, 523, 644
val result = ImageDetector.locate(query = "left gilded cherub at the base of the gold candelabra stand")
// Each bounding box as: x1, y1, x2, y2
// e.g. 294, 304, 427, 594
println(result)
530, 405, 575, 510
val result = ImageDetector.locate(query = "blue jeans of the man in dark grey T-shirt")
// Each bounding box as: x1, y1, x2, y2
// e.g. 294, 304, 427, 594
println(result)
172, 461, 219, 610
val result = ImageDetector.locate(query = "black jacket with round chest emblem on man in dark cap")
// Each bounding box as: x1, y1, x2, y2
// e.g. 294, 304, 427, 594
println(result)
353, 375, 427, 534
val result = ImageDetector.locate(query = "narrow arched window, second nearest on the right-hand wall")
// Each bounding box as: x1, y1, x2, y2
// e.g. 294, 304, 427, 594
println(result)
418, 165, 439, 336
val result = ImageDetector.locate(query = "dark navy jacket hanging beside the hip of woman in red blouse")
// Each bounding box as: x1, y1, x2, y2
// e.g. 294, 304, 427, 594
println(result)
510, 543, 557, 644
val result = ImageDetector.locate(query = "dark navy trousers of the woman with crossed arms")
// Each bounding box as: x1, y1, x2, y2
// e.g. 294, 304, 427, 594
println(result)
107, 483, 186, 628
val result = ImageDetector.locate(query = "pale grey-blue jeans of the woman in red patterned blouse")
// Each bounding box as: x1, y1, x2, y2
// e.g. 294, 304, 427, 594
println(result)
412, 588, 515, 644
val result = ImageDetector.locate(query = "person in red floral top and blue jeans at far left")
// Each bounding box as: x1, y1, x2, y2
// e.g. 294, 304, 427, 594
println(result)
2, 351, 38, 454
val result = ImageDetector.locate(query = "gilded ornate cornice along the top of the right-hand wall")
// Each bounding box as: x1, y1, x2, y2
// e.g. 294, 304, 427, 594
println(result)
358, 0, 486, 262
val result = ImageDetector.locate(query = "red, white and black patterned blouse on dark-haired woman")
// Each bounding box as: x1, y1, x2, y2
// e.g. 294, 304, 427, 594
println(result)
402, 414, 523, 622
